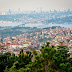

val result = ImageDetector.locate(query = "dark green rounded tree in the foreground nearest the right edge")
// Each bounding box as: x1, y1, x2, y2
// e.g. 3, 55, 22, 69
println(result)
54, 45, 71, 72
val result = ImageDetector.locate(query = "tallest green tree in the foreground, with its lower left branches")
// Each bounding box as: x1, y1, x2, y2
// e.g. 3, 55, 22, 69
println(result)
26, 42, 56, 72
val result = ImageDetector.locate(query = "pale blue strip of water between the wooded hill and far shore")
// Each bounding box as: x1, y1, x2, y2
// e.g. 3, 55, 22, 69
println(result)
0, 23, 72, 28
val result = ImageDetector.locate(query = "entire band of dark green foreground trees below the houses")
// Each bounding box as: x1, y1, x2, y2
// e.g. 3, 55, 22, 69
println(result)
0, 42, 72, 72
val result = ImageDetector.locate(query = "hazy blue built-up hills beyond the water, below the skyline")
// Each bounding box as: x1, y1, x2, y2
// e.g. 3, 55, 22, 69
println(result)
0, 11, 72, 24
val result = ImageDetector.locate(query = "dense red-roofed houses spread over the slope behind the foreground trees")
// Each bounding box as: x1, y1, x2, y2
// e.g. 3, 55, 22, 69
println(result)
0, 27, 72, 57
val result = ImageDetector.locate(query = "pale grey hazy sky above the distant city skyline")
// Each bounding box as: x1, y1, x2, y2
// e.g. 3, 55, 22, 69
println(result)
0, 0, 72, 11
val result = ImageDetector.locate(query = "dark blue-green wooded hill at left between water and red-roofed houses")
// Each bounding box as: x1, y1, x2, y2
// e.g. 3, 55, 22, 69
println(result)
0, 26, 40, 38
